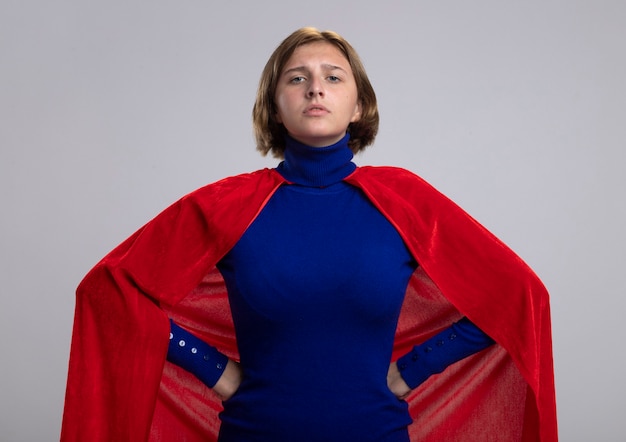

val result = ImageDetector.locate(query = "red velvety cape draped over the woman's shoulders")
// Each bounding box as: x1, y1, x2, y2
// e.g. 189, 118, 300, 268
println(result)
61, 167, 557, 442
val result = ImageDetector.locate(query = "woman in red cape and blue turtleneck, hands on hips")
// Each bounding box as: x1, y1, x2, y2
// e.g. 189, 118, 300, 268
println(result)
62, 28, 557, 442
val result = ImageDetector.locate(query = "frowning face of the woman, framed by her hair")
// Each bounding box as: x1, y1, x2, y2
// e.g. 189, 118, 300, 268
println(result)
274, 42, 361, 147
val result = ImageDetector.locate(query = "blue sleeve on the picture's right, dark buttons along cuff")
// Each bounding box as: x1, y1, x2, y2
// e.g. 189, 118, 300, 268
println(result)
398, 318, 495, 389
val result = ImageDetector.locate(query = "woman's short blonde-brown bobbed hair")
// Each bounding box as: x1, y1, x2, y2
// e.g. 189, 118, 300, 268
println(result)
252, 27, 379, 158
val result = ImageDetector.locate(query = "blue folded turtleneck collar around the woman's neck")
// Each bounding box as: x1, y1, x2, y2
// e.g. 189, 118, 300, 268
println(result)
276, 133, 356, 187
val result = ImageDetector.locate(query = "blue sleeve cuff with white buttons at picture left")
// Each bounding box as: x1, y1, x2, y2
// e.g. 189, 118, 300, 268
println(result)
167, 319, 228, 388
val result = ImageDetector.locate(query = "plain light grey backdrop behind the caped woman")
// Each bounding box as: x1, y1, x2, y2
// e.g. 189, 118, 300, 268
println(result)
0, 0, 626, 442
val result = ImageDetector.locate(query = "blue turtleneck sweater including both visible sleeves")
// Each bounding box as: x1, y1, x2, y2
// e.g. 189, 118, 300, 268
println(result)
168, 135, 492, 442
